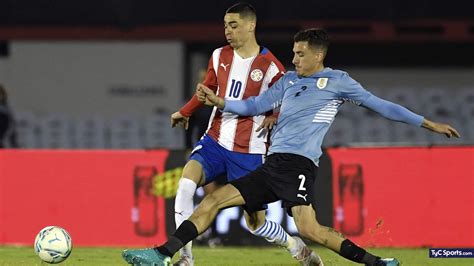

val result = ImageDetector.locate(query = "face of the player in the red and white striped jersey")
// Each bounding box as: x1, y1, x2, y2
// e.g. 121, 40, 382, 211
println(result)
224, 13, 255, 49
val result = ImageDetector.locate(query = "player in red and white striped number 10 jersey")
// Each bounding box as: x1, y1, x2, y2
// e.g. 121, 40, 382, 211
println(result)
171, 3, 320, 265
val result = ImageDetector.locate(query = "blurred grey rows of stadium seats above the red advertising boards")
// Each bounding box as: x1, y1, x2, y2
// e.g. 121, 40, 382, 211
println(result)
9, 88, 474, 149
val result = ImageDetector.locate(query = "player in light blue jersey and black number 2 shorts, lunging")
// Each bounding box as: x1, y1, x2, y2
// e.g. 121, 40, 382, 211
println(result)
123, 29, 460, 266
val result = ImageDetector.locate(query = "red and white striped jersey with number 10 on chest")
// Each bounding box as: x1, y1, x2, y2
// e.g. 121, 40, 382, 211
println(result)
180, 45, 285, 154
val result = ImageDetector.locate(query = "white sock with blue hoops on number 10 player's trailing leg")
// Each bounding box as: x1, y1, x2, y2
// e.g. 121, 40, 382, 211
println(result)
250, 220, 295, 249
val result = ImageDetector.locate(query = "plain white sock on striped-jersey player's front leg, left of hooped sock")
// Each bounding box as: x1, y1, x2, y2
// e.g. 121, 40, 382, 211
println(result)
174, 177, 197, 258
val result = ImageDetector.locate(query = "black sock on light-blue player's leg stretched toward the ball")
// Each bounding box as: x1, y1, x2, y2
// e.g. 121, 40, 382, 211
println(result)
155, 220, 198, 257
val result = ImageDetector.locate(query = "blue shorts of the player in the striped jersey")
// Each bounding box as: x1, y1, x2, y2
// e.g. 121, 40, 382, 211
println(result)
189, 135, 264, 184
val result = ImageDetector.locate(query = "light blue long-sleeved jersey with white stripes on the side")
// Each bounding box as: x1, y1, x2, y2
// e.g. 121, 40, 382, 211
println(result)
224, 68, 423, 165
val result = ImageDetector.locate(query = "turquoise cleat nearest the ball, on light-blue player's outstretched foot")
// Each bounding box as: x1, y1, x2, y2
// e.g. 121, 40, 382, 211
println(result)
122, 248, 171, 266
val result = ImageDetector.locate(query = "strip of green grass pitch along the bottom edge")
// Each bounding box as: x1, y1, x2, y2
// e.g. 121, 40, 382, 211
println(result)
0, 246, 474, 266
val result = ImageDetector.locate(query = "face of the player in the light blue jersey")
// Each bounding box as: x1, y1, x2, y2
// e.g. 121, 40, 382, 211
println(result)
293, 42, 323, 76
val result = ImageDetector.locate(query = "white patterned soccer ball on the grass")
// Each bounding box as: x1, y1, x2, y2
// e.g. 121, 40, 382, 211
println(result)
35, 226, 72, 263
